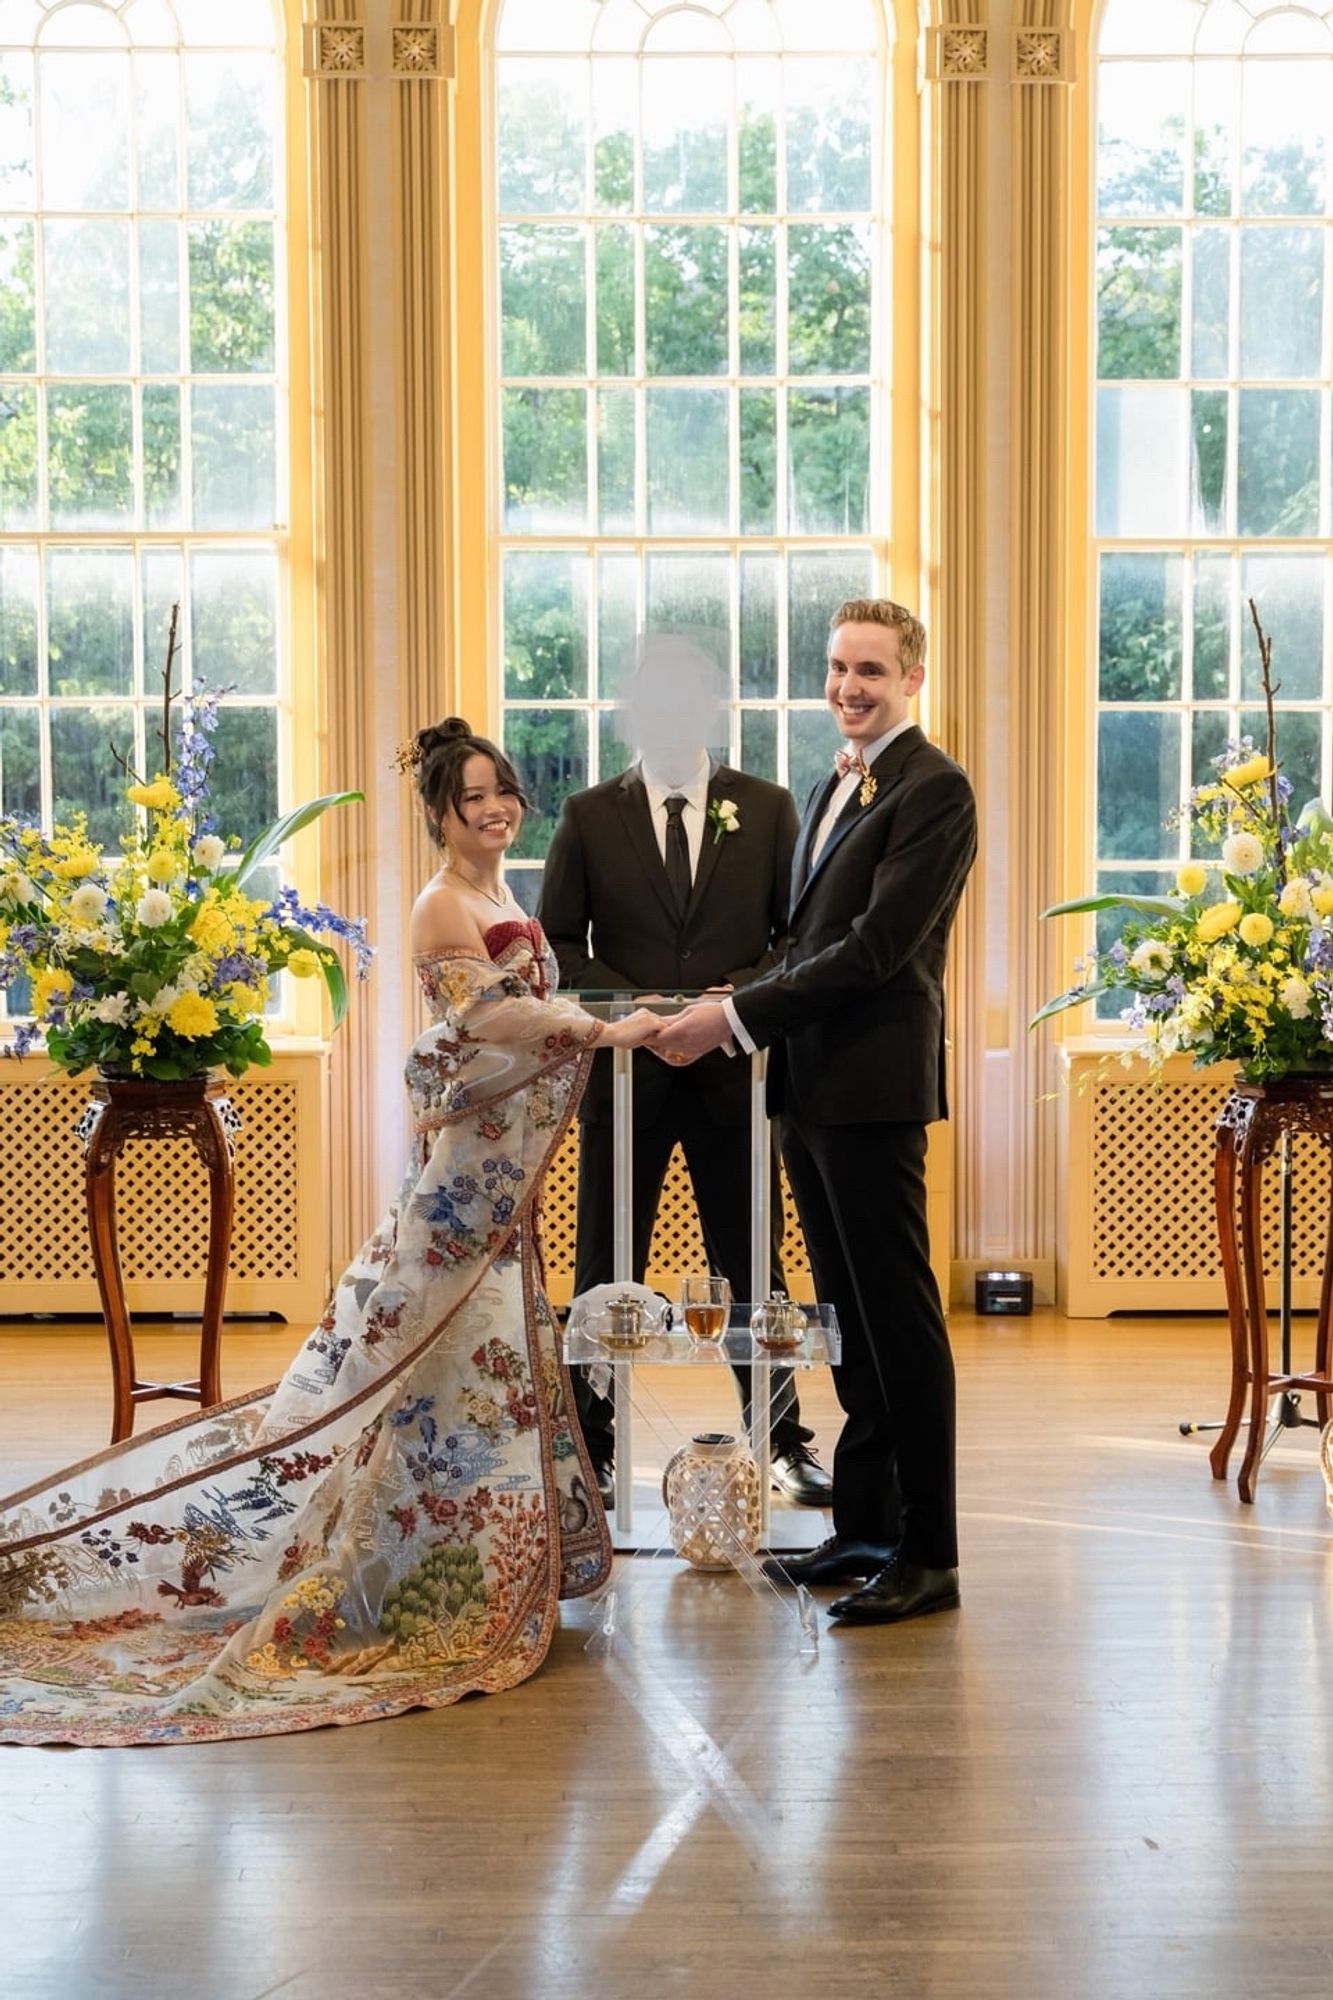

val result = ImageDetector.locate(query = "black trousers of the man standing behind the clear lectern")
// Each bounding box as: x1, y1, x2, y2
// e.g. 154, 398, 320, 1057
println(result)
572, 1092, 815, 1466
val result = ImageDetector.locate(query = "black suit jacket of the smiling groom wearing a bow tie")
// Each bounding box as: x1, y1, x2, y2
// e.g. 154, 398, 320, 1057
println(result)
735, 726, 977, 1128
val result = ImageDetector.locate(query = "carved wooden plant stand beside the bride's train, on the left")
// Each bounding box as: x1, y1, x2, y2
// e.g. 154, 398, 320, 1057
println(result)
80, 1076, 236, 1444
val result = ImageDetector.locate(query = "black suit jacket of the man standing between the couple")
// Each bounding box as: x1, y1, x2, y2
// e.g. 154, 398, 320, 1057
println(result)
538, 764, 797, 1126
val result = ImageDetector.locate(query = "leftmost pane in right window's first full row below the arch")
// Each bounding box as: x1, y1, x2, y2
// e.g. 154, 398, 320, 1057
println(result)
1097, 62, 1191, 216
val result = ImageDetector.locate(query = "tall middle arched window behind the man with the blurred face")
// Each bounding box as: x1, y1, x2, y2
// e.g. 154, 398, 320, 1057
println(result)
494, 0, 889, 900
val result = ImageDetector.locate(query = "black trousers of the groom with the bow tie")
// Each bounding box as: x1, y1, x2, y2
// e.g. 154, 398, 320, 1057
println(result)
781, 1118, 959, 1570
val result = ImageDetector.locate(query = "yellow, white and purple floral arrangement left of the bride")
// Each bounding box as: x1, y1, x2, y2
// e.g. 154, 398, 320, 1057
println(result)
0, 610, 370, 1082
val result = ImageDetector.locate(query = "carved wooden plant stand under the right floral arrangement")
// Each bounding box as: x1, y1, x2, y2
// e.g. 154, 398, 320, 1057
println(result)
1209, 1074, 1333, 1500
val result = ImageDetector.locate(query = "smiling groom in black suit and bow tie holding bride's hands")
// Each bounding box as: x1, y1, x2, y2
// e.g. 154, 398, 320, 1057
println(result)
652, 598, 977, 1624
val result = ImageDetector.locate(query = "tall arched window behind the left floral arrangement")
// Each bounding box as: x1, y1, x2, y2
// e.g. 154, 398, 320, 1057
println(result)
0, 0, 286, 892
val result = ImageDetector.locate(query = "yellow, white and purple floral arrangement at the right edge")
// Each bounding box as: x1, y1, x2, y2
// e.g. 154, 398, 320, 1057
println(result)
1033, 600, 1333, 1082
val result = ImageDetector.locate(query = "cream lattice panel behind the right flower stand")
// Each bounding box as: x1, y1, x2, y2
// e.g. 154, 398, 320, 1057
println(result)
1089, 1084, 1329, 1286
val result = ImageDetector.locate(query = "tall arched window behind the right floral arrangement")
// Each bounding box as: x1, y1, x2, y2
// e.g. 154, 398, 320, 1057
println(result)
1095, 0, 1333, 992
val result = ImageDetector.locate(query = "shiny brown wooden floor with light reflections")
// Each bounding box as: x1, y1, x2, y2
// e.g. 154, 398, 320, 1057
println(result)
0, 1312, 1333, 2000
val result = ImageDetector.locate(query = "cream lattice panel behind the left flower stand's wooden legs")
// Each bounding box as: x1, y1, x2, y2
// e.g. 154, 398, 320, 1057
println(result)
0, 1078, 302, 1286
